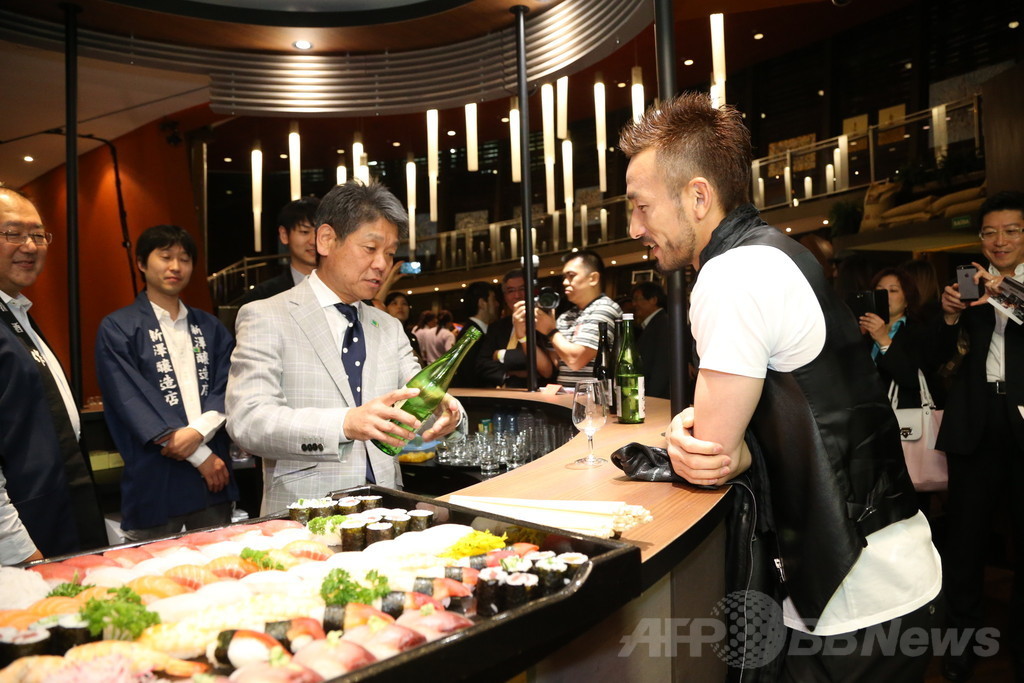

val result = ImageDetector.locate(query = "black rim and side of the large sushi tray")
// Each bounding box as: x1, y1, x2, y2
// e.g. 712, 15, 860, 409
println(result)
317, 485, 640, 683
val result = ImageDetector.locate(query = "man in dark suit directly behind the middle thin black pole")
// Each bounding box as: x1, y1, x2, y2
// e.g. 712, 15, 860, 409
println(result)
476, 268, 554, 388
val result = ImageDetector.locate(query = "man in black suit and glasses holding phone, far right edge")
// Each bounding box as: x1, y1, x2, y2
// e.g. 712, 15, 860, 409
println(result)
936, 188, 1024, 681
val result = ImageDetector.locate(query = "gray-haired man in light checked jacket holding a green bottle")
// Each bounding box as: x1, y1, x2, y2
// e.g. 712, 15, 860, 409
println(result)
226, 181, 466, 514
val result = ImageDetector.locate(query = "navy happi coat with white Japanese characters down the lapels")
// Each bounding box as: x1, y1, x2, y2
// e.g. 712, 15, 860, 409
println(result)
96, 292, 239, 529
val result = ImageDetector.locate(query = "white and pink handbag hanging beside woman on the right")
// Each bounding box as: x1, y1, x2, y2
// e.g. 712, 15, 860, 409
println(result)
889, 370, 949, 490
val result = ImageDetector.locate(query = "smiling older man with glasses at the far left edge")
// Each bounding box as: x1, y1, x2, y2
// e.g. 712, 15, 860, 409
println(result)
0, 187, 106, 564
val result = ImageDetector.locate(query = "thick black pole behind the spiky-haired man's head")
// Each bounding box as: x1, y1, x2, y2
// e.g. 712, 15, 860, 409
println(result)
654, 0, 693, 415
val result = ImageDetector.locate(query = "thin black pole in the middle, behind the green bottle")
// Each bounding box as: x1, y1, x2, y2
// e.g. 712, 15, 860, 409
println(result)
510, 5, 538, 391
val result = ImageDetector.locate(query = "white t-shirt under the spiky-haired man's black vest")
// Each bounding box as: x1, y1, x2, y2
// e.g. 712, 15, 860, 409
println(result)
690, 245, 942, 636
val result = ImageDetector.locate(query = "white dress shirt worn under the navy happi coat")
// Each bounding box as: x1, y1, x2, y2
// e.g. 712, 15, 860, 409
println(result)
150, 300, 226, 467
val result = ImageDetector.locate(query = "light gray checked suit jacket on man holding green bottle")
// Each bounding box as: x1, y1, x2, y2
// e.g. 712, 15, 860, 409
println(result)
226, 281, 454, 514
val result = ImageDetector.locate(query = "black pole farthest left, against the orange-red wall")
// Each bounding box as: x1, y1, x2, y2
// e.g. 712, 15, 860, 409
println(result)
60, 3, 82, 407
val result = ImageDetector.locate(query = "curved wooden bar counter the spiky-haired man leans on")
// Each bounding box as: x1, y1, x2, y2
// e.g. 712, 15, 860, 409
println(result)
453, 389, 729, 683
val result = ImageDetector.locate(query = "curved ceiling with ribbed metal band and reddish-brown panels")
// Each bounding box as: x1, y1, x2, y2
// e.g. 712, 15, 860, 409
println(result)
0, 0, 909, 186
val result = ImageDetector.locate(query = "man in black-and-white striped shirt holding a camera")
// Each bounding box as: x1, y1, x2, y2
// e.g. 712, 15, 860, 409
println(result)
537, 250, 623, 387
